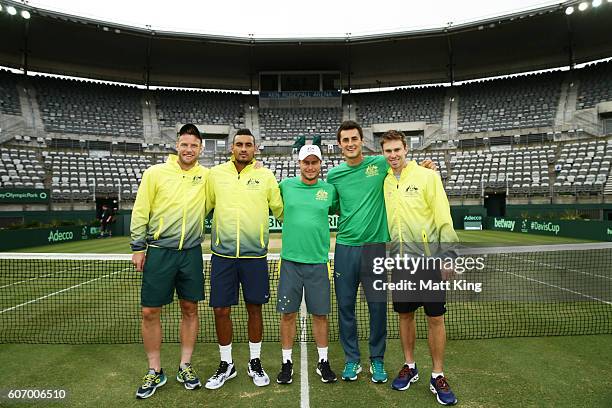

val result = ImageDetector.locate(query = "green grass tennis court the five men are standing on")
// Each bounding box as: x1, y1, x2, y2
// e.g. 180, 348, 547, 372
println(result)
0, 231, 612, 407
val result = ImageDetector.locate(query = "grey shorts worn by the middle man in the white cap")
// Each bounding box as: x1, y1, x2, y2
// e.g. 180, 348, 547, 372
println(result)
276, 259, 331, 315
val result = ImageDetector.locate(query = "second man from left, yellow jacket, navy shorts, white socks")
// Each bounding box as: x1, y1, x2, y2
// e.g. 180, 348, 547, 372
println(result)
205, 129, 283, 389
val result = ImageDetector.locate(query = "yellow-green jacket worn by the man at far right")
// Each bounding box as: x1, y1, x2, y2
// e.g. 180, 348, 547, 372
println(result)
384, 161, 459, 255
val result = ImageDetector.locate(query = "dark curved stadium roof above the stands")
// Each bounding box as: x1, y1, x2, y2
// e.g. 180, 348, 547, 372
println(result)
0, 0, 612, 90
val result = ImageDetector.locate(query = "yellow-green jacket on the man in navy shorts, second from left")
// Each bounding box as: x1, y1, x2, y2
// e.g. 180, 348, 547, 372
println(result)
206, 157, 283, 258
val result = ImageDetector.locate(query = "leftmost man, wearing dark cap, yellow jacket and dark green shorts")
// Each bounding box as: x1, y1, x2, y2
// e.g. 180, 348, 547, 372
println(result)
131, 124, 208, 398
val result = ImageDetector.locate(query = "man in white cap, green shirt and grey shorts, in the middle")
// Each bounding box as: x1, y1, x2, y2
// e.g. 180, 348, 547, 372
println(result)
276, 145, 338, 384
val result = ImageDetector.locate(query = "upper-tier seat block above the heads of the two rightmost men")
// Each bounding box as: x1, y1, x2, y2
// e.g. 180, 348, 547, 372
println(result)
353, 87, 446, 127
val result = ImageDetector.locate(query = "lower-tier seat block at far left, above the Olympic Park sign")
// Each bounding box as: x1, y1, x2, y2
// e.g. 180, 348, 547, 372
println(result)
0, 147, 46, 188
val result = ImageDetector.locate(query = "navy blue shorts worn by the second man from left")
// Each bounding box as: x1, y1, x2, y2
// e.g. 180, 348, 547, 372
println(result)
210, 254, 270, 307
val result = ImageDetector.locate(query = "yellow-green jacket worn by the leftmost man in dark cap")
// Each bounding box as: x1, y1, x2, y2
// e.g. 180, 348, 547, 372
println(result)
130, 154, 209, 252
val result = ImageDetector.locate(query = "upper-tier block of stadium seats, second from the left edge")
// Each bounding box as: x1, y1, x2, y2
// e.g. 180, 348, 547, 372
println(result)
31, 77, 143, 138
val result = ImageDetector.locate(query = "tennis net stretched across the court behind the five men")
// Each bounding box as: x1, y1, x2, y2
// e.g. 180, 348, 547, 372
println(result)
0, 243, 612, 344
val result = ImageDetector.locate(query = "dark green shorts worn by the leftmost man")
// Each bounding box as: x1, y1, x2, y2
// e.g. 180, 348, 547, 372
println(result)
140, 245, 204, 307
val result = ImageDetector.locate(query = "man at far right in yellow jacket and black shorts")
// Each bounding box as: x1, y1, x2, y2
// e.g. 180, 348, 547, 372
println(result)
380, 130, 458, 405
